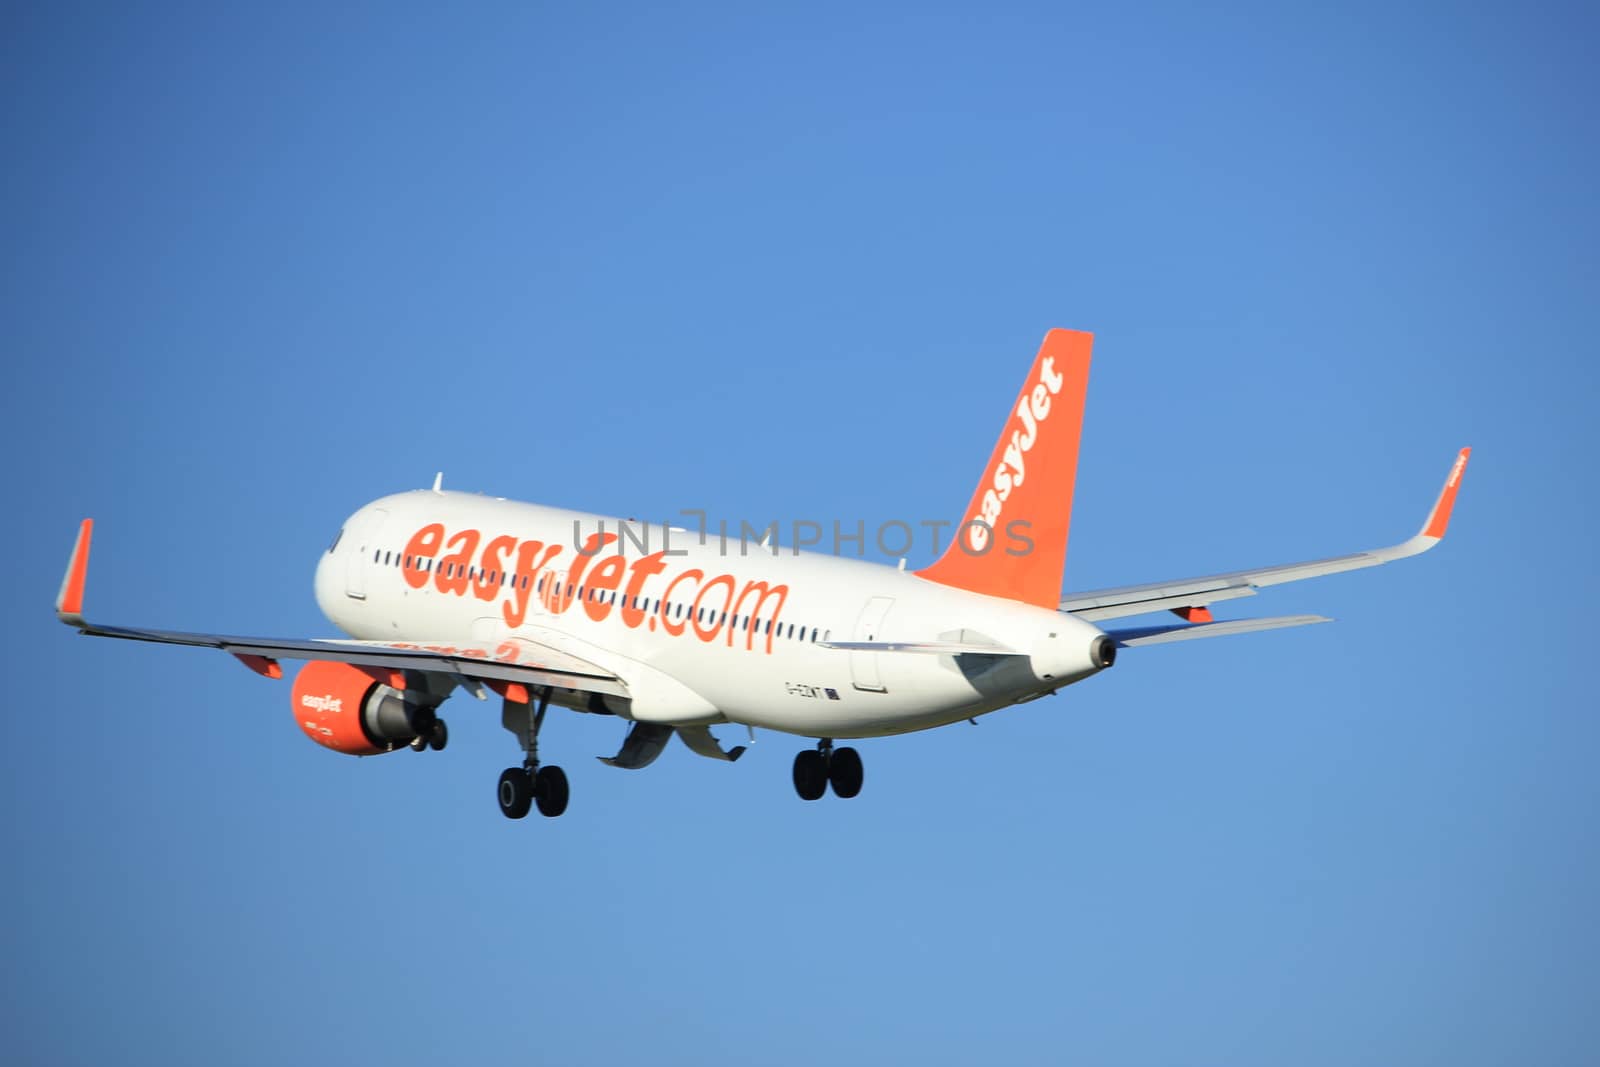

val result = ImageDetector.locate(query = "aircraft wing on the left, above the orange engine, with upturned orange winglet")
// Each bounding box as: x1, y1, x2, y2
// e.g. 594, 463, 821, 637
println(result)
56, 518, 629, 696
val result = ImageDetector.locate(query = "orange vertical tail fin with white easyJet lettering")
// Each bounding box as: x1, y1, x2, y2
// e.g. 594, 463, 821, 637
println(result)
917, 330, 1094, 608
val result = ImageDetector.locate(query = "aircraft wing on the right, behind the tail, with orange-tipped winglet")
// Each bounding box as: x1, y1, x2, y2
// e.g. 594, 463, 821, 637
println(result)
1061, 448, 1472, 620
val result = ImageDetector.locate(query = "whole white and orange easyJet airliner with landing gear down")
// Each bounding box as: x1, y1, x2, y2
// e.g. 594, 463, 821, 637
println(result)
56, 330, 1470, 819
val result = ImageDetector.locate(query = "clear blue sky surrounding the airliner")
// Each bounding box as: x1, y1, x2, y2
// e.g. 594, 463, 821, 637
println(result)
0, 3, 1600, 1065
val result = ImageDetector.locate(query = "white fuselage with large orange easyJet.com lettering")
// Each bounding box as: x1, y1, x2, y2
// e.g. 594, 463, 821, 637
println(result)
317, 490, 1101, 737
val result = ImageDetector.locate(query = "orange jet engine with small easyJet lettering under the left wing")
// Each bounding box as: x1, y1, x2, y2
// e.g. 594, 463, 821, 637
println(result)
291, 659, 437, 755
